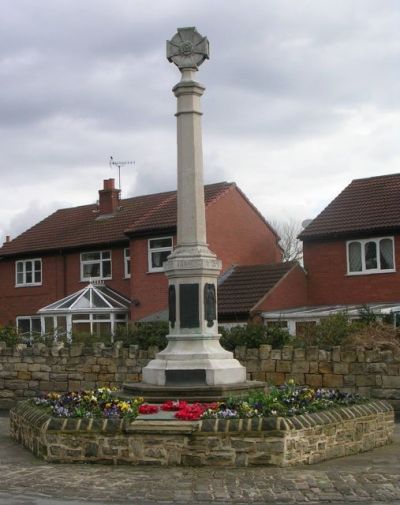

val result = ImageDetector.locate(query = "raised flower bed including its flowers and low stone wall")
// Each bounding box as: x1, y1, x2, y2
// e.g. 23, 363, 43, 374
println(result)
10, 382, 394, 466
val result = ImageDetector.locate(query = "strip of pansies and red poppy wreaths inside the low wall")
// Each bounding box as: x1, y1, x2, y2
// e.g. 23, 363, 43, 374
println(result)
33, 380, 365, 421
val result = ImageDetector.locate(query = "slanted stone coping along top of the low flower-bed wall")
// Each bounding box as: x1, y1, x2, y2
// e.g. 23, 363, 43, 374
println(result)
11, 400, 394, 434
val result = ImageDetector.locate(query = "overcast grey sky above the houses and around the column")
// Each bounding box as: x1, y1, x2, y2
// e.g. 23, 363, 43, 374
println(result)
0, 0, 400, 242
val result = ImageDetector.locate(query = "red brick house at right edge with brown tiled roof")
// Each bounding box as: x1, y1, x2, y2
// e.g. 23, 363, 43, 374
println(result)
264, 174, 400, 332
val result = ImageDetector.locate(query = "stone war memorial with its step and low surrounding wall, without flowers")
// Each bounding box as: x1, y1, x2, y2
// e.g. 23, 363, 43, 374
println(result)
10, 27, 394, 467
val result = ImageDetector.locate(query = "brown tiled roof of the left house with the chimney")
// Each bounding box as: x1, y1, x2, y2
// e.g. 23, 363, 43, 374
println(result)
0, 182, 235, 256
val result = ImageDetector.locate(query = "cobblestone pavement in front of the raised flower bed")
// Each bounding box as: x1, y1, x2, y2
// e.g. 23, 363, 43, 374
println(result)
0, 414, 400, 505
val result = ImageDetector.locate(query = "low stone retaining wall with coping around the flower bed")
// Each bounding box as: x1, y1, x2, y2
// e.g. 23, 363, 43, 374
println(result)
10, 401, 394, 467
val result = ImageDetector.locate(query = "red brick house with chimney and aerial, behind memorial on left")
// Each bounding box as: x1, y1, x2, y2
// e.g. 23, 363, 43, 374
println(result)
0, 179, 282, 331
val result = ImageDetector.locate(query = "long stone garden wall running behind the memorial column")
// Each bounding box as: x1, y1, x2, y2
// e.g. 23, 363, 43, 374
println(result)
0, 342, 400, 413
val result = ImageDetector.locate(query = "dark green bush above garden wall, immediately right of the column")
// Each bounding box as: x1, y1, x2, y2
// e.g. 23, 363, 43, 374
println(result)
219, 323, 291, 351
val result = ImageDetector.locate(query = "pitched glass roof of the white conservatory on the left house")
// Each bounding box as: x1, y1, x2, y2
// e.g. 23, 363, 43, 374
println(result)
38, 283, 131, 314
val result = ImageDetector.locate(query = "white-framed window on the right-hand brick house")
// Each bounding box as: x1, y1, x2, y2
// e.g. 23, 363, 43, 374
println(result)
347, 237, 395, 275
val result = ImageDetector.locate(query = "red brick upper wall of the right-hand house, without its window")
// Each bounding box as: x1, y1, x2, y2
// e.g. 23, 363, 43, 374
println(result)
303, 236, 400, 305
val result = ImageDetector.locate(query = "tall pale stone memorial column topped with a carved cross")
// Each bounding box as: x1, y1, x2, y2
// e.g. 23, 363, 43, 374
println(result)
143, 28, 246, 386
